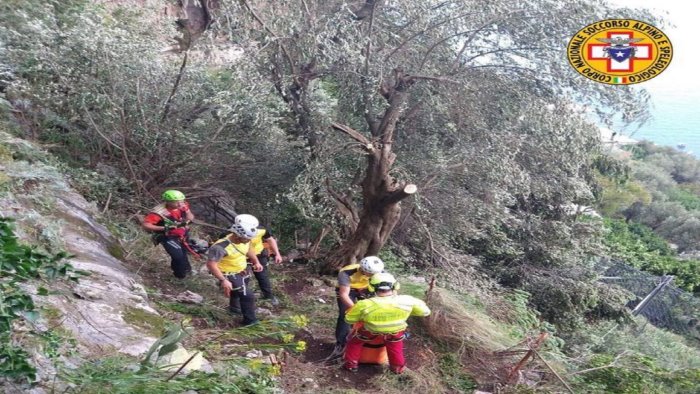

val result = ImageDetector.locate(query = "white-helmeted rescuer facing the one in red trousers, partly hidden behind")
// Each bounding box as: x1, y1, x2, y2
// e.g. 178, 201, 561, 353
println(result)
333, 256, 384, 355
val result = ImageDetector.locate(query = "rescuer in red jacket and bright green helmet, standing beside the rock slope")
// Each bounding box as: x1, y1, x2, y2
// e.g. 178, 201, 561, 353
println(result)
141, 190, 194, 278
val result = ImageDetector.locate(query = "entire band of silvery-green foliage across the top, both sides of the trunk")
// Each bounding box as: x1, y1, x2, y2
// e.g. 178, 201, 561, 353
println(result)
0, 0, 664, 330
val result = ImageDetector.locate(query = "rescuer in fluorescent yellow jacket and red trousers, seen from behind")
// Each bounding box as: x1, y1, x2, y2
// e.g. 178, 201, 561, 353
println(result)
344, 272, 430, 374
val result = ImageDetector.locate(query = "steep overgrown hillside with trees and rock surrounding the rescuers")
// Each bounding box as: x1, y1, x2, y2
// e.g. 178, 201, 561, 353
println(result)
0, 0, 700, 394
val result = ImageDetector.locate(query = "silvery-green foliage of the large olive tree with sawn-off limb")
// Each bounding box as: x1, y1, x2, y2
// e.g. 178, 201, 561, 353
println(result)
218, 0, 654, 324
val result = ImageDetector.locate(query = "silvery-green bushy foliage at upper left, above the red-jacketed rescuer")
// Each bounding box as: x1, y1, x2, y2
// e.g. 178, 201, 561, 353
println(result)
0, 0, 295, 209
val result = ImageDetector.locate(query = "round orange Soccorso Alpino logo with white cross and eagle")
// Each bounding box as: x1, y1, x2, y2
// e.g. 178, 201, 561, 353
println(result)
567, 19, 673, 85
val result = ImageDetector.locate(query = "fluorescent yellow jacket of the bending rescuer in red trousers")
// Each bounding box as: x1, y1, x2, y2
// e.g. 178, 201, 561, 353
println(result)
345, 295, 430, 334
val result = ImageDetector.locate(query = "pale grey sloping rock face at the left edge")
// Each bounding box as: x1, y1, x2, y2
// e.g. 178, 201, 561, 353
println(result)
0, 133, 162, 384
